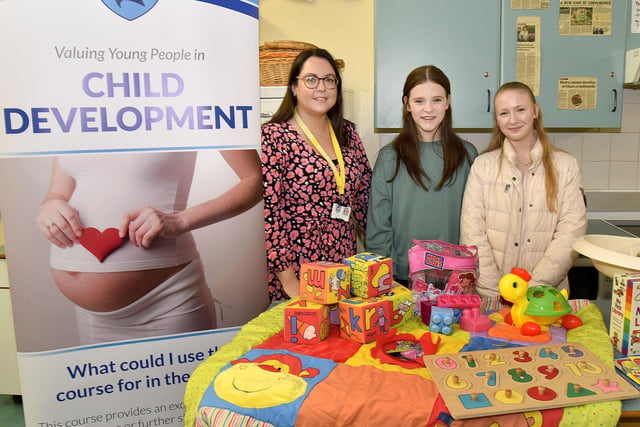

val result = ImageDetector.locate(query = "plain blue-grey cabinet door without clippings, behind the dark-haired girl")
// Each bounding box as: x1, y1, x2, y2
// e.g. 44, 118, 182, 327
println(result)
374, 0, 500, 132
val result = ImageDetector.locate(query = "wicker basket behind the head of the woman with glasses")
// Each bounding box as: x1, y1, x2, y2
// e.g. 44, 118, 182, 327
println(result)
260, 40, 344, 86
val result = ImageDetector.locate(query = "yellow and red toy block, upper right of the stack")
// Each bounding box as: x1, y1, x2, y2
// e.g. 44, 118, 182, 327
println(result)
344, 252, 393, 298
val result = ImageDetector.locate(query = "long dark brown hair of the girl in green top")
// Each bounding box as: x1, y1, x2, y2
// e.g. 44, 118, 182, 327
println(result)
388, 65, 471, 191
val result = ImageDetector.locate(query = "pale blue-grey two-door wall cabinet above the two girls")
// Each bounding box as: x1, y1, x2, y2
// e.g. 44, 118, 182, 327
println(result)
374, 0, 629, 132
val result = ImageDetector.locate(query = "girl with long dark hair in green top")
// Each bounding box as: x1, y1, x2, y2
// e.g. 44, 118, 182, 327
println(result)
366, 65, 478, 284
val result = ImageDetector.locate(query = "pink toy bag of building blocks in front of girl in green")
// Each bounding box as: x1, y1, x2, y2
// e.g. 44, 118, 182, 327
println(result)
408, 240, 478, 316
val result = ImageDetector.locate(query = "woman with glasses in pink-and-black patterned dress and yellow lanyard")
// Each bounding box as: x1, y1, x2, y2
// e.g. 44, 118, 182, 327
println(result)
262, 49, 371, 301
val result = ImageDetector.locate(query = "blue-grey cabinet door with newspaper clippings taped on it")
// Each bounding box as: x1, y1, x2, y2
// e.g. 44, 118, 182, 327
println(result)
501, 0, 627, 128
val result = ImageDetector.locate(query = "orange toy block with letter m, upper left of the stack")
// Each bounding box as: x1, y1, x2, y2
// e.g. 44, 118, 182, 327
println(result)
300, 261, 351, 304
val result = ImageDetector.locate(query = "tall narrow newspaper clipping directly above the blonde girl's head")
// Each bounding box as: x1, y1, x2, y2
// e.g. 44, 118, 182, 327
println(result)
516, 16, 540, 96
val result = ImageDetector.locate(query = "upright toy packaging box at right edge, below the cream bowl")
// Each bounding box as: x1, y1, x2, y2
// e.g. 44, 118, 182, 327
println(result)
609, 273, 640, 356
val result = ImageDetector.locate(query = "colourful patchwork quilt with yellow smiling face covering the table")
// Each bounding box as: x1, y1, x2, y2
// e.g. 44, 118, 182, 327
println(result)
184, 302, 621, 427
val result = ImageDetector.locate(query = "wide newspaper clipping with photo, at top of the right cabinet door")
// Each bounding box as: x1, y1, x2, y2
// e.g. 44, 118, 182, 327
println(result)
558, 0, 613, 36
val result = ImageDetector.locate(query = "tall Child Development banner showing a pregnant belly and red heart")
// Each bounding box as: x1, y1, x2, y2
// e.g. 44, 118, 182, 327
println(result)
0, 0, 268, 427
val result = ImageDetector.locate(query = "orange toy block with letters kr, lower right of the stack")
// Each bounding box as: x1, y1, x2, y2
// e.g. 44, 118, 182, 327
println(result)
338, 297, 393, 344
